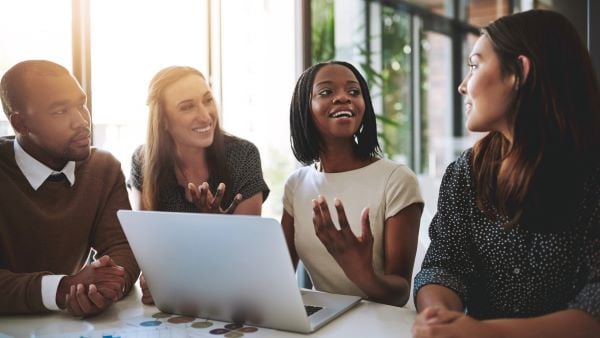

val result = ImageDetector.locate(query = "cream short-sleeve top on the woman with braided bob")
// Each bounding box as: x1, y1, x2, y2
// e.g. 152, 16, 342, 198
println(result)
283, 159, 423, 297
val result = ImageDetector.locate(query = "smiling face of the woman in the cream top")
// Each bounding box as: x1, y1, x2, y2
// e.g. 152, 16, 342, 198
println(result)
311, 64, 365, 141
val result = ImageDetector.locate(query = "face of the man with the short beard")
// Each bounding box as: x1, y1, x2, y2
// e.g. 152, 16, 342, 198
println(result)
17, 73, 91, 170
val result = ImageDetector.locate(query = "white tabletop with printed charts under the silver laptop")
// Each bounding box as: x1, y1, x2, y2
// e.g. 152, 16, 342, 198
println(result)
0, 287, 416, 338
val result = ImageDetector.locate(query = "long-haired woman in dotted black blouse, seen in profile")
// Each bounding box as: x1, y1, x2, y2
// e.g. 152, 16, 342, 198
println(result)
413, 10, 600, 338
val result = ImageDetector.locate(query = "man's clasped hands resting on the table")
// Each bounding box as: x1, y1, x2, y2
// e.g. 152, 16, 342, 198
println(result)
56, 256, 125, 317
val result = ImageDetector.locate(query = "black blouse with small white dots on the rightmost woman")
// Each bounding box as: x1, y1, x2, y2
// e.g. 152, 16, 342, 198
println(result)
414, 150, 600, 321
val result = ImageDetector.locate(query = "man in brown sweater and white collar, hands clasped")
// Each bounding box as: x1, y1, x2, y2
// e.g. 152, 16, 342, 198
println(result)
0, 60, 139, 316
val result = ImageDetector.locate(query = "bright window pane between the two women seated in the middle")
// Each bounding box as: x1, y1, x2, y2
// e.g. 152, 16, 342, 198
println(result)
220, 0, 296, 219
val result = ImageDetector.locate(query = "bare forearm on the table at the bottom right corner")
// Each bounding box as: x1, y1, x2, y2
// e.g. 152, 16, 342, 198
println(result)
485, 309, 600, 338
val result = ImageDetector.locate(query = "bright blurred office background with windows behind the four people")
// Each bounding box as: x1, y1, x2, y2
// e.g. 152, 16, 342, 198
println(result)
0, 0, 600, 220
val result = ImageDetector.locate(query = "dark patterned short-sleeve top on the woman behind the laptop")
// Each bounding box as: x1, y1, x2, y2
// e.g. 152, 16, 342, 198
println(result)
134, 135, 269, 212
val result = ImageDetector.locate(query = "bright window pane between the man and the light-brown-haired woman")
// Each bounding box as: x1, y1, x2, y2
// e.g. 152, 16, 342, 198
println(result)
90, 0, 210, 177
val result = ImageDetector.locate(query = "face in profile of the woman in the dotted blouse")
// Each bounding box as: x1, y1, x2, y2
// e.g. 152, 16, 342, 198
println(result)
458, 35, 516, 139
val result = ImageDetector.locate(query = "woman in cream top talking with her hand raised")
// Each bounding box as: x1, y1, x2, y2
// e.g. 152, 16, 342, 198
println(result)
281, 61, 423, 306
